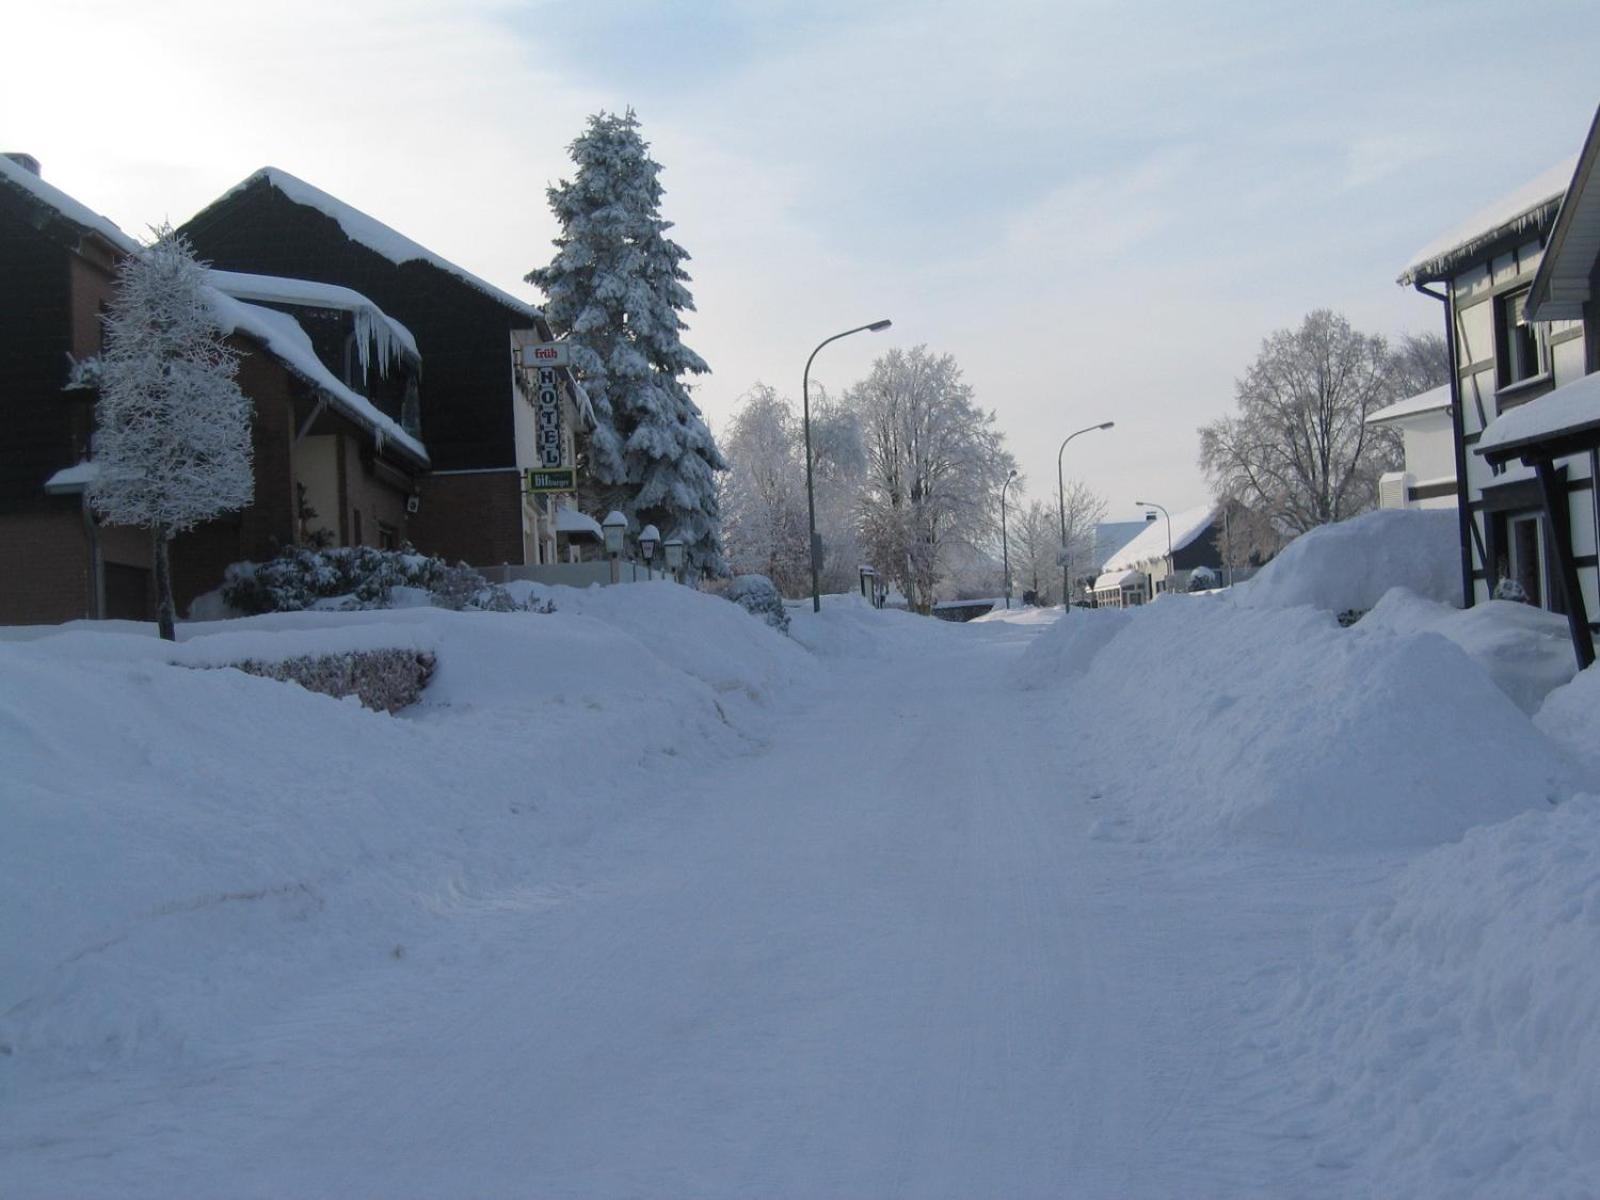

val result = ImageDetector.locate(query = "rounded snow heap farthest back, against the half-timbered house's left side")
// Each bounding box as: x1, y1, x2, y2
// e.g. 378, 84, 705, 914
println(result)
1234, 509, 1461, 613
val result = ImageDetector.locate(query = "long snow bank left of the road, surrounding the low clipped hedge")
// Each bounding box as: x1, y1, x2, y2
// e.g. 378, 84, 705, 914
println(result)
0, 587, 810, 1093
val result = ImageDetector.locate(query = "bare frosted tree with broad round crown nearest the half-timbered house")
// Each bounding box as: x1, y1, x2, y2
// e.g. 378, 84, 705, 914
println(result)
1200, 310, 1411, 534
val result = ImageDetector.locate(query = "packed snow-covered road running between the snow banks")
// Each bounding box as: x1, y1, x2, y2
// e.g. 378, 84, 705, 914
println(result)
6, 624, 1388, 1197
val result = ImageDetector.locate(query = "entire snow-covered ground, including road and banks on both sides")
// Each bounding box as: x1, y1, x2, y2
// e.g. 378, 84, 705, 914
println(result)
0, 518, 1600, 1197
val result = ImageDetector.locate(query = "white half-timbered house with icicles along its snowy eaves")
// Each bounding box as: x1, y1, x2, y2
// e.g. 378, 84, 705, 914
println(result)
1398, 107, 1600, 662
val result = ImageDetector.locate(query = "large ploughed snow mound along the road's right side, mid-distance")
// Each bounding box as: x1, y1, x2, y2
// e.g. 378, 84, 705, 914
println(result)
1018, 597, 1576, 850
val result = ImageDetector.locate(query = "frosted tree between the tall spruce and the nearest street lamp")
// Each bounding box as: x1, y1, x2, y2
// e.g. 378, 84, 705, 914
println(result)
718, 384, 811, 595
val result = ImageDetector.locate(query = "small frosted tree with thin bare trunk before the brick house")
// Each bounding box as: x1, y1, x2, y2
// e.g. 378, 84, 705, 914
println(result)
90, 226, 254, 642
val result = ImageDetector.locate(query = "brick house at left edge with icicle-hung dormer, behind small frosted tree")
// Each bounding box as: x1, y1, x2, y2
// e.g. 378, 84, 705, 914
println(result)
0, 155, 429, 624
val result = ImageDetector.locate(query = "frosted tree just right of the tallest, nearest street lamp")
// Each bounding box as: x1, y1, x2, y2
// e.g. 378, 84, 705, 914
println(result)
848, 346, 1016, 613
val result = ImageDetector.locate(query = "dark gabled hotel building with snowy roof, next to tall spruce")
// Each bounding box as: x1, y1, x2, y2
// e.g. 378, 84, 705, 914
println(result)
182, 166, 594, 566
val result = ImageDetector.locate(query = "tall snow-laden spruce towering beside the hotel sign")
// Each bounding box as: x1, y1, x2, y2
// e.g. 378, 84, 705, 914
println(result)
526, 109, 726, 574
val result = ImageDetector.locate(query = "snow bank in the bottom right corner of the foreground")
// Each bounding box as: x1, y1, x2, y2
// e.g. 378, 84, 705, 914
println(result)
1266, 795, 1600, 1200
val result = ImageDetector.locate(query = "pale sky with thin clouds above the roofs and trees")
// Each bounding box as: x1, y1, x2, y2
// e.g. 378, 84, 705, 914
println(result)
0, 0, 1600, 518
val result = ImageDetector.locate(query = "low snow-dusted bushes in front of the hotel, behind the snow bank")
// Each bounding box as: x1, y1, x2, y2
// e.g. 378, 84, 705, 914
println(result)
222, 546, 518, 613
